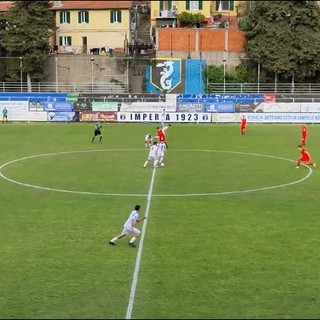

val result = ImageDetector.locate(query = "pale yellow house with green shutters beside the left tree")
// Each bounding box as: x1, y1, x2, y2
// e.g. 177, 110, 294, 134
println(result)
52, 1, 133, 54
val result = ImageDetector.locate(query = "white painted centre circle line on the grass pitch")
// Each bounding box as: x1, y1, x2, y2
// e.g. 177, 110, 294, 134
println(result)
0, 149, 312, 197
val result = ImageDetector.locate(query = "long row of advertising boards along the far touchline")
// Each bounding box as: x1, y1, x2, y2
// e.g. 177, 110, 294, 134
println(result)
0, 93, 320, 123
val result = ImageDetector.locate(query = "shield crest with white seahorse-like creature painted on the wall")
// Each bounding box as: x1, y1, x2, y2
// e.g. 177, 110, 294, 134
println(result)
150, 58, 181, 93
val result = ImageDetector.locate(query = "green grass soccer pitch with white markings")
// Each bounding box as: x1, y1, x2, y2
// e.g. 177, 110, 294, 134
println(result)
0, 123, 320, 319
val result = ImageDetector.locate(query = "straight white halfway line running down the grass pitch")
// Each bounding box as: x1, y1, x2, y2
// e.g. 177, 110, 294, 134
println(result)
126, 168, 156, 319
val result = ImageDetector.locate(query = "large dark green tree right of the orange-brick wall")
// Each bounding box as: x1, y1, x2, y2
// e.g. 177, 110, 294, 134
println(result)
244, 1, 320, 81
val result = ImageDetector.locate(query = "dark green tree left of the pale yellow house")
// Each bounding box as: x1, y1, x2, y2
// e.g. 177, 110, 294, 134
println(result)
0, 1, 56, 91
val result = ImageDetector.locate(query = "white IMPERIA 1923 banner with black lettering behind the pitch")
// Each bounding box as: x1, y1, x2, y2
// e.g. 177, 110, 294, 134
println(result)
117, 112, 211, 123
